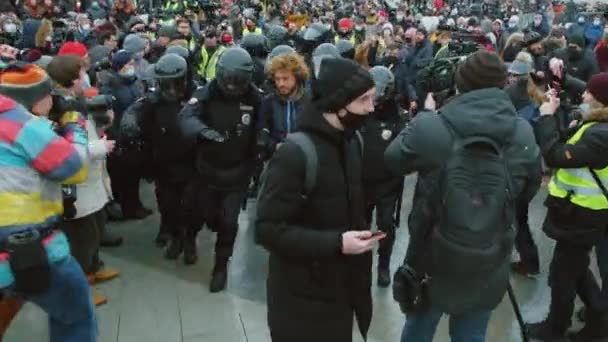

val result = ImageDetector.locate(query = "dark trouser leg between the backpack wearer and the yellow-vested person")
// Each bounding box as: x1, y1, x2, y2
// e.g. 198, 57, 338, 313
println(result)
515, 198, 540, 269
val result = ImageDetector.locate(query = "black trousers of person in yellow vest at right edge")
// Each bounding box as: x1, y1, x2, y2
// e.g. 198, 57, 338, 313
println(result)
545, 219, 602, 332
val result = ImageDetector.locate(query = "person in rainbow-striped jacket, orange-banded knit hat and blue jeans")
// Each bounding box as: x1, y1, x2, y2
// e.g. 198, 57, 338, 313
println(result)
0, 64, 97, 342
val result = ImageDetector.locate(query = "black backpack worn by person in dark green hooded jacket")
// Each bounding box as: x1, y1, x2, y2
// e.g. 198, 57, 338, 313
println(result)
429, 115, 515, 277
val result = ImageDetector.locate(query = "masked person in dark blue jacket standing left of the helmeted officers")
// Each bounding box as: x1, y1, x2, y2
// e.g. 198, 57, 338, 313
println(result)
100, 50, 152, 219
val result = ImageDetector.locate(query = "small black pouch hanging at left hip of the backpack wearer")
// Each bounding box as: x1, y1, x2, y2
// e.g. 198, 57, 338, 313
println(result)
393, 264, 428, 314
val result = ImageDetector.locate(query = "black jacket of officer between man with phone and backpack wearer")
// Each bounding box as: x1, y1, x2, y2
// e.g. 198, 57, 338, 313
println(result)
361, 101, 405, 196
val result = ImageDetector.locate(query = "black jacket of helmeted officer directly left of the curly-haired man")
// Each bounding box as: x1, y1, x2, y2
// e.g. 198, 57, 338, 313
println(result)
180, 80, 262, 190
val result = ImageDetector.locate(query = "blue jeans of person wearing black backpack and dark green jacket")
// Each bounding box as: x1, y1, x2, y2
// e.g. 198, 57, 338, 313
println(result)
401, 309, 492, 342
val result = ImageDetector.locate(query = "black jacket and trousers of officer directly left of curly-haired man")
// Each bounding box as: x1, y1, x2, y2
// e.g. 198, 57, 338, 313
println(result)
181, 80, 261, 259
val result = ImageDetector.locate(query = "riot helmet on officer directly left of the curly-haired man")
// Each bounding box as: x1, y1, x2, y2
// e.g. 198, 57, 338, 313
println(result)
215, 47, 253, 97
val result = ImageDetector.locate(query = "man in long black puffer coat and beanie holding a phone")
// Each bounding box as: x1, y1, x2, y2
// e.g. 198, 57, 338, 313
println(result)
255, 58, 383, 342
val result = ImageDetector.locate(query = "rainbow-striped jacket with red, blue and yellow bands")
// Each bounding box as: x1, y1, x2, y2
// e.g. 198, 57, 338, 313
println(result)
0, 95, 87, 230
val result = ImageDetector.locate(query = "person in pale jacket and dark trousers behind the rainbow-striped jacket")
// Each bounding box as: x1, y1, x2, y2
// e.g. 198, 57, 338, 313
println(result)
47, 55, 122, 305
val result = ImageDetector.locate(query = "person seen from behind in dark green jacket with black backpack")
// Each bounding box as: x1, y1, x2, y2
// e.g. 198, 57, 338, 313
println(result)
384, 51, 539, 342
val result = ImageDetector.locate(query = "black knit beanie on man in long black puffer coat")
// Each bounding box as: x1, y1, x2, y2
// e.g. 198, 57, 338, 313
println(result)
312, 58, 374, 113
